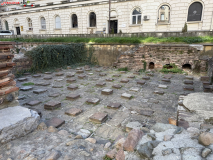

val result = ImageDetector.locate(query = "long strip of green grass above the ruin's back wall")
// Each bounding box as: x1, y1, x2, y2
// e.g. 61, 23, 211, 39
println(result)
0, 36, 213, 44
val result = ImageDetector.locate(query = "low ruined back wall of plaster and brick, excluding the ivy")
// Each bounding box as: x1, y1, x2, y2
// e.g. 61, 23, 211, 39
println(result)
9, 42, 213, 72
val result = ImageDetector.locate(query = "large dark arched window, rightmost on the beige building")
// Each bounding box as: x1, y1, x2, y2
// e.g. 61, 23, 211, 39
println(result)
187, 2, 203, 22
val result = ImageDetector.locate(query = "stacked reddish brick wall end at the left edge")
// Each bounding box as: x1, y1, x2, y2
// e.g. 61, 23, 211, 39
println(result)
0, 42, 19, 109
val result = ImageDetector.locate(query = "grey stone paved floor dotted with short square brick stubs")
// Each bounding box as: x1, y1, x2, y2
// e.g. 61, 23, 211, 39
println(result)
0, 67, 202, 160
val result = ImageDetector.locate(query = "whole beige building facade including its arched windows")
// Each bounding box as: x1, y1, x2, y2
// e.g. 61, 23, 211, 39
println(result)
0, 0, 213, 34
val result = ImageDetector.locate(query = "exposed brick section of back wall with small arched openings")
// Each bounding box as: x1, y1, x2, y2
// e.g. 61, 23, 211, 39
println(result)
115, 45, 207, 72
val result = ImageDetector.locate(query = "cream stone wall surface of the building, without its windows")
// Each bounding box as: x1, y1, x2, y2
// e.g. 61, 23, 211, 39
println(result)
1, 0, 213, 34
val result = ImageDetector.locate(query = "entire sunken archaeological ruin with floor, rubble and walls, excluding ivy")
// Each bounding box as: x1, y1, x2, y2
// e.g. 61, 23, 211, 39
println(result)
0, 38, 213, 160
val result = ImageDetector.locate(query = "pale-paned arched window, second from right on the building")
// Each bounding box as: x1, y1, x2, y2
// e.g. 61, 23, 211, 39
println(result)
158, 5, 170, 23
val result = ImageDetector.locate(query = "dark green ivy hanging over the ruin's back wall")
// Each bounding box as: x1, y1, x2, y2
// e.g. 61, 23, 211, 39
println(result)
26, 43, 92, 72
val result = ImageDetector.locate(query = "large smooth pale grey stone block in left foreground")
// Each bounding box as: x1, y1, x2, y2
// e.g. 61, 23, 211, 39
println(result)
0, 106, 40, 144
